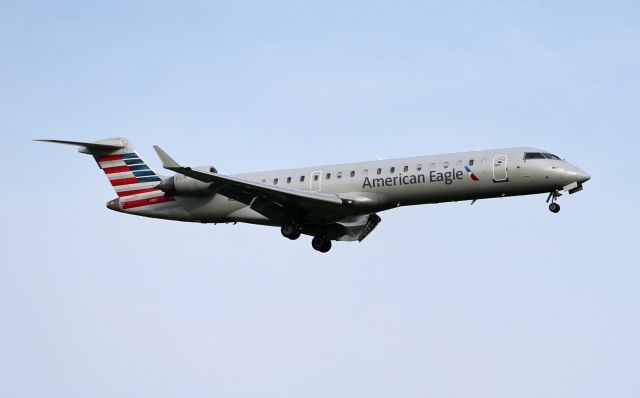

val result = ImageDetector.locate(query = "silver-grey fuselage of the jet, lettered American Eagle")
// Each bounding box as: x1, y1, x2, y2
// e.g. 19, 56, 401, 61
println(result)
125, 148, 588, 225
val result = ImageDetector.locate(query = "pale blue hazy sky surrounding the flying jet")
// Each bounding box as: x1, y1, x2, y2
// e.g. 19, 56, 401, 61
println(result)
0, 1, 640, 398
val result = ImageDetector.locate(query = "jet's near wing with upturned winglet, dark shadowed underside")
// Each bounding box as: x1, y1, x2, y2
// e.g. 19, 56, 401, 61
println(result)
153, 146, 346, 223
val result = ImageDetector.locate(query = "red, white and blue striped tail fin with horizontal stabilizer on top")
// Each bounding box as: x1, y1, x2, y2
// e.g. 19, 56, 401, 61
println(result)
36, 138, 161, 197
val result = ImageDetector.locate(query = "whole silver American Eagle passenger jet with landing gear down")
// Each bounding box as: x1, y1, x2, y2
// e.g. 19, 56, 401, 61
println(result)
36, 137, 591, 253
